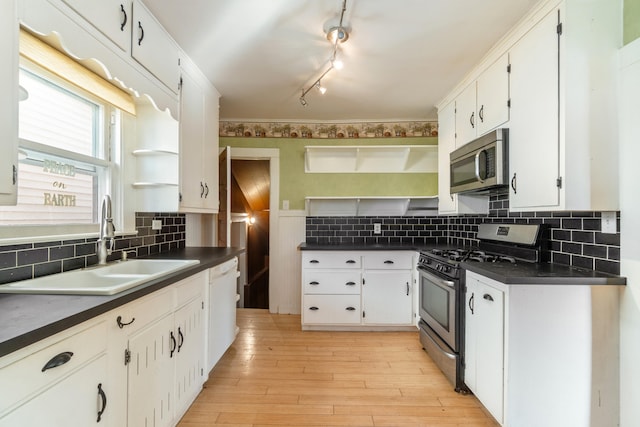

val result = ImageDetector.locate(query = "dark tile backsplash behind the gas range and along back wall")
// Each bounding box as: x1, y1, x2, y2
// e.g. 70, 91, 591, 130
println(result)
304, 193, 620, 274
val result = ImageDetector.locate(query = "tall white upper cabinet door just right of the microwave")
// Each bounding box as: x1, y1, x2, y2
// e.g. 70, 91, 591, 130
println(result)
509, 11, 560, 210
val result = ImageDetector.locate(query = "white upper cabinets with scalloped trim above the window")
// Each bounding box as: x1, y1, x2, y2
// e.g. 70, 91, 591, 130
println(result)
18, 0, 180, 118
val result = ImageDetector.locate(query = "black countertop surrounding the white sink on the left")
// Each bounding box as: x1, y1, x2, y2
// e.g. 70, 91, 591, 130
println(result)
0, 247, 244, 357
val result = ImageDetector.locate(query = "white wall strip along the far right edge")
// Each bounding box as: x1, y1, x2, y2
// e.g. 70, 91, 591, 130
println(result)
620, 39, 640, 427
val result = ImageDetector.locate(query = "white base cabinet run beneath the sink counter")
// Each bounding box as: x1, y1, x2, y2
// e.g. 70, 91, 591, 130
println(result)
0, 264, 237, 427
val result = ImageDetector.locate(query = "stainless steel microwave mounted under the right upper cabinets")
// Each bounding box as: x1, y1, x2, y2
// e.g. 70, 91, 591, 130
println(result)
449, 129, 509, 194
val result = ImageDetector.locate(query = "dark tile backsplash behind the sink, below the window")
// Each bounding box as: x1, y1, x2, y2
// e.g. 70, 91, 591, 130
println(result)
0, 212, 185, 283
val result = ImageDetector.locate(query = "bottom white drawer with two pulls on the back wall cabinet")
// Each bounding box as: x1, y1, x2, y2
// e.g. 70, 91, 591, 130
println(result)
302, 295, 361, 325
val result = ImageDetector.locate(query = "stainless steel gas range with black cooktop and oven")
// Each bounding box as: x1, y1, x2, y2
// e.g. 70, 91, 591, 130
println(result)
418, 224, 548, 394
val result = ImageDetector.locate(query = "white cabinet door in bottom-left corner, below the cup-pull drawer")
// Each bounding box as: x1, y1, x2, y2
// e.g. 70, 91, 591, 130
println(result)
0, 354, 108, 427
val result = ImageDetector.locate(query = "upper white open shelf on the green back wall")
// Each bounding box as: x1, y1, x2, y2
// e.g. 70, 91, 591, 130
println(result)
305, 145, 438, 173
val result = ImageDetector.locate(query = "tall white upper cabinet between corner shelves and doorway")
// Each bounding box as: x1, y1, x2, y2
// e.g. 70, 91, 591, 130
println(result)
180, 54, 219, 213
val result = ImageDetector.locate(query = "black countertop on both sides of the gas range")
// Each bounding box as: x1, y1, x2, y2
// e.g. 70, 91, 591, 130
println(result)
298, 243, 627, 285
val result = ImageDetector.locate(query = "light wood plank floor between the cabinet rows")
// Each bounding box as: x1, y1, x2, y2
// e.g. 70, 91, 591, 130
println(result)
179, 309, 498, 427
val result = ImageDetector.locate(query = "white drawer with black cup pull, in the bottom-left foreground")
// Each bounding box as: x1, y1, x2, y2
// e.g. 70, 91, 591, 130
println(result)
0, 321, 107, 414
